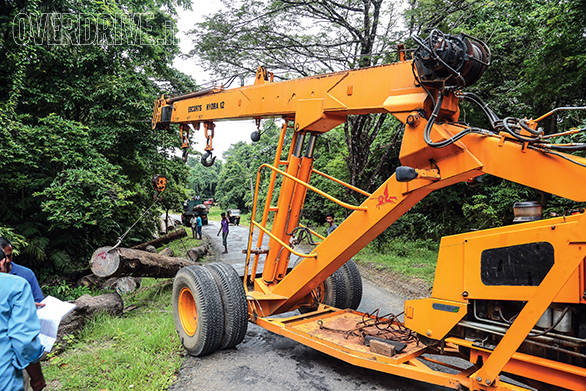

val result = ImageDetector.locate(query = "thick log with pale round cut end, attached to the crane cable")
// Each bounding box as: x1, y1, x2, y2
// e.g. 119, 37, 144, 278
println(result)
90, 247, 194, 278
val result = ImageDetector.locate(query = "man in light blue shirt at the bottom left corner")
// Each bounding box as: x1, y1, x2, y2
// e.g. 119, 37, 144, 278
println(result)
0, 250, 46, 391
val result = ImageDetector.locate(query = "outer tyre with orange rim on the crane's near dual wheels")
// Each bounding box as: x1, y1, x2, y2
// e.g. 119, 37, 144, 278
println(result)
173, 265, 224, 356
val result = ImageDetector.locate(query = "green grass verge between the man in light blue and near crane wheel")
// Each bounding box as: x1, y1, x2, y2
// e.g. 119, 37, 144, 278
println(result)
43, 278, 182, 391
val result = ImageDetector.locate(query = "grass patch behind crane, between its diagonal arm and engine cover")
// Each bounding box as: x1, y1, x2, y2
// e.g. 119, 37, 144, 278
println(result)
354, 239, 438, 285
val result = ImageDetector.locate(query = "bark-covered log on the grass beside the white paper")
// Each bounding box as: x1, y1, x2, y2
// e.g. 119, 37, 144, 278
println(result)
51, 293, 124, 354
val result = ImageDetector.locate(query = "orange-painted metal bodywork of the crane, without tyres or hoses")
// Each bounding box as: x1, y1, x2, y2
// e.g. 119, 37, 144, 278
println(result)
153, 53, 586, 390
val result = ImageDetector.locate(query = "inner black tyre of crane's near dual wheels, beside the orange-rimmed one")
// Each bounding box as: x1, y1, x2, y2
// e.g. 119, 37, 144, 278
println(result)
205, 262, 248, 349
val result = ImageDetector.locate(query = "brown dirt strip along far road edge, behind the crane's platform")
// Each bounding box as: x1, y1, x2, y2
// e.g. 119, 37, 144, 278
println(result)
358, 262, 431, 299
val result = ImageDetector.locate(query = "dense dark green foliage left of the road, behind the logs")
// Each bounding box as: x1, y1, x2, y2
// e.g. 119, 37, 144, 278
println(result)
0, 0, 195, 272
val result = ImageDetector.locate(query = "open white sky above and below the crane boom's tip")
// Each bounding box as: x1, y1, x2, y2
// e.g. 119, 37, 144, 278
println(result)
173, 0, 256, 158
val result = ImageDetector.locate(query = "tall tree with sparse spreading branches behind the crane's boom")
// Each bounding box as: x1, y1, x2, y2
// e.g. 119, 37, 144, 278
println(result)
191, 0, 402, 192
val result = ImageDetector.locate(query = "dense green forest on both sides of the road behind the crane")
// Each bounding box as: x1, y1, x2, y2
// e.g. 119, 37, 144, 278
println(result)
0, 0, 586, 272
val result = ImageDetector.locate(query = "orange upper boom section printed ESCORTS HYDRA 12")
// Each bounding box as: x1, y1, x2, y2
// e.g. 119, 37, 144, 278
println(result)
153, 61, 427, 132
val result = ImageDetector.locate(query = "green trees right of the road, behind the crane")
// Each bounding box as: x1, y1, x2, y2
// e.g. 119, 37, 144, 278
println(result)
192, 0, 586, 240
